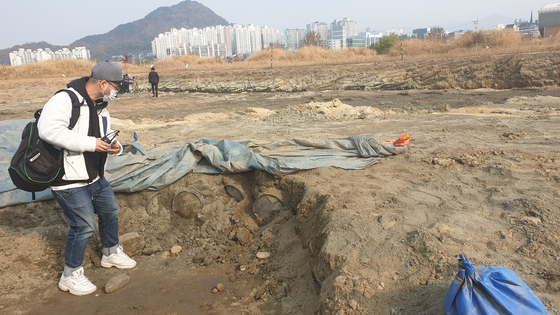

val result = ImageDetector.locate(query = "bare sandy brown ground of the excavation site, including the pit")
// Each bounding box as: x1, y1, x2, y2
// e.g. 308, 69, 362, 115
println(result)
0, 54, 560, 315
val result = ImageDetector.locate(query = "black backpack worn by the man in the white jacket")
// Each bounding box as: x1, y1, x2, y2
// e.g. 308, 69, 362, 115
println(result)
8, 90, 83, 200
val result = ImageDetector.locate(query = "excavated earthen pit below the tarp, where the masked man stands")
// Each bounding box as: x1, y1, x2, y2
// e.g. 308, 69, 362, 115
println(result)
0, 171, 332, 314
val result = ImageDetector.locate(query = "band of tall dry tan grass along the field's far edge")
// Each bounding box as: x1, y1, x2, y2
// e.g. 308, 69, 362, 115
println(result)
5, 31, 560, 79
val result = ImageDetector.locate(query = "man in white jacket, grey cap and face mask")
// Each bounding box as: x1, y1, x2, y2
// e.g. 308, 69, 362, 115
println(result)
37, 62, 136, 295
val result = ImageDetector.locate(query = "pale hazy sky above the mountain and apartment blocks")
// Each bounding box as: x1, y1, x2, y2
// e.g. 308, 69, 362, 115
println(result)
0, 0, 555, 49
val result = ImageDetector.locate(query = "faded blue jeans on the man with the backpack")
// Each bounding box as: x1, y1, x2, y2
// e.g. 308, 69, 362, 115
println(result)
52, 178, 120, 268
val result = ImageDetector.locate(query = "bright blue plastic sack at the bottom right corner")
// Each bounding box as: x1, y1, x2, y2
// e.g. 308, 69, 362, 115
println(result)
443, 255, 548, 315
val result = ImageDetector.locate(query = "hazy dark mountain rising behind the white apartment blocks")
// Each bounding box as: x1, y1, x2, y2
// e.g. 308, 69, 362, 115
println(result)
0, 0, 229, 65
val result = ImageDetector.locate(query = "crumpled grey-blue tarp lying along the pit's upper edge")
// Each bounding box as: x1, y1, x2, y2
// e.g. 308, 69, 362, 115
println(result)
0, 119, 407, 207
